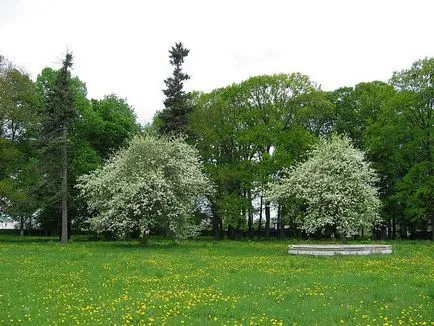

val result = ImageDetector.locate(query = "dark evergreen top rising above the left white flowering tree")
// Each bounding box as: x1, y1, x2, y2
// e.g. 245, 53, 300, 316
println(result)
158, 42, 192, 134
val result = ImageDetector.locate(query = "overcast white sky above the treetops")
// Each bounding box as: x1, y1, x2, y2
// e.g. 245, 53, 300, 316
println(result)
0, 0, 434, 122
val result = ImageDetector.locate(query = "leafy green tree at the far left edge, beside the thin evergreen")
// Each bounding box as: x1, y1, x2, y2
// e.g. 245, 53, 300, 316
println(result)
0, 57, 39, 226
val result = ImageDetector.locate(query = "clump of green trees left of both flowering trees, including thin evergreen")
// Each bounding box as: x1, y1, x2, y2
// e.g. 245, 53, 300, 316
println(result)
0, 53, 142, 238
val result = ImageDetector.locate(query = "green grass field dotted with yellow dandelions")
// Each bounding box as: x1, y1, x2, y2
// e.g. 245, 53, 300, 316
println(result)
0, 236, 434, 325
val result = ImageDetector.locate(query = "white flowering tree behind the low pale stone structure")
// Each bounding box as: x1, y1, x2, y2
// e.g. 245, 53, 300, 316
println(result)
268, 135, 380, 241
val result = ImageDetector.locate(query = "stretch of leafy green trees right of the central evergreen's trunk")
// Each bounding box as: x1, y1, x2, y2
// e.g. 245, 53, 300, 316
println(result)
154, 44, 434, 238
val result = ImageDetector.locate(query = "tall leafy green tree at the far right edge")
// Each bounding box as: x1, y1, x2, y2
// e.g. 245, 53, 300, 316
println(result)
391, 58, 434, 234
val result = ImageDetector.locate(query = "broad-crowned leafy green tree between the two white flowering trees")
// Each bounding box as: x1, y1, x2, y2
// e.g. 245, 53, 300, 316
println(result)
191, 73, 333, 237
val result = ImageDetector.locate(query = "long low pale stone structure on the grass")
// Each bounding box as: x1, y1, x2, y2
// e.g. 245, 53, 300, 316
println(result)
288, 244, 392, 256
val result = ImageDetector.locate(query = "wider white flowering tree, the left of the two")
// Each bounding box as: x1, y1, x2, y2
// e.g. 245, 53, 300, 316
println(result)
77, 135, 212, 241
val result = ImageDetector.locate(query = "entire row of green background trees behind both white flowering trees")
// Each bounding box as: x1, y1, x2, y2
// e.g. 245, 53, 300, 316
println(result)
0, 43, 434, 239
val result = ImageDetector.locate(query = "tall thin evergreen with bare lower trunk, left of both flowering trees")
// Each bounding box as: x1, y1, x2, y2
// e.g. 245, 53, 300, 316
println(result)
42, 53, 76, 243
